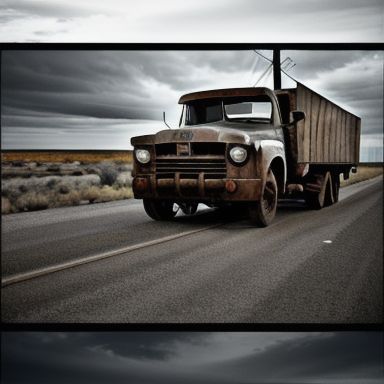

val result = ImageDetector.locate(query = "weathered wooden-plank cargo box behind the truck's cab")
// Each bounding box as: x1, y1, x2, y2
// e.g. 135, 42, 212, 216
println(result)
276, 83, 361, 166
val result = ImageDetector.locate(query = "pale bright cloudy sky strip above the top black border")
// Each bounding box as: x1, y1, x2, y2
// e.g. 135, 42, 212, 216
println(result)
0, 0, 383, 43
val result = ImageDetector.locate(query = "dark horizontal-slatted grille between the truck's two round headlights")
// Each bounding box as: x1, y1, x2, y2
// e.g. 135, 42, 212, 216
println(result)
156, 156, 227, 178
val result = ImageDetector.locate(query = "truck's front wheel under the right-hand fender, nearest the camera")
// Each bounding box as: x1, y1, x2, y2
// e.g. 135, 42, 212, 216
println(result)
249, 170, 278, 227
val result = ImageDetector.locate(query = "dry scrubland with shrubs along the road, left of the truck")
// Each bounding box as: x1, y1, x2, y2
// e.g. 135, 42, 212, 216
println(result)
1, 160, 133, 214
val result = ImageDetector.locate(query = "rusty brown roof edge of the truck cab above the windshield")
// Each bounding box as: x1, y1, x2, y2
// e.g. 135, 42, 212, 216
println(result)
179, 87, 273, 104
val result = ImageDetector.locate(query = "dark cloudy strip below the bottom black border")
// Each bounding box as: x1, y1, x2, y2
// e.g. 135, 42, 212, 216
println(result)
2, 332, 384, 384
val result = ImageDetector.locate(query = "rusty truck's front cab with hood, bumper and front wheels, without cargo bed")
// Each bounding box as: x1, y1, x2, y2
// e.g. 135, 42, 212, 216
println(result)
132, 88, 292, 226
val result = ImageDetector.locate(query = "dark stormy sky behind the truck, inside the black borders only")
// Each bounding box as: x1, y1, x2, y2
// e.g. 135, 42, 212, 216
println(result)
1, 50, 383, 157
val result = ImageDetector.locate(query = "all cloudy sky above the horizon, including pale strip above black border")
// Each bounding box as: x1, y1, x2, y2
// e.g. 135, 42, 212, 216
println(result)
0, 0, 384, 161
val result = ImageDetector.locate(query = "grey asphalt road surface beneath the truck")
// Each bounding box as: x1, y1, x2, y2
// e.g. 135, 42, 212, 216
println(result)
1, 178, 383, 324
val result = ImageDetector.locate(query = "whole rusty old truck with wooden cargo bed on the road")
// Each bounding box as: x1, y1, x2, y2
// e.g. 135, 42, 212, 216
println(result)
131, 82, 361, 227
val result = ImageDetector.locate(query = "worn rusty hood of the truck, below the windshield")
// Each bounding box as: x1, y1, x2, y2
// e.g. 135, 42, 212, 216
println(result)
155, 121, 283, 144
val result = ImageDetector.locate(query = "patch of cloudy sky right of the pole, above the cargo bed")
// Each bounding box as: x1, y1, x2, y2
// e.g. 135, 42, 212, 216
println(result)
282, 51, 383, 135
